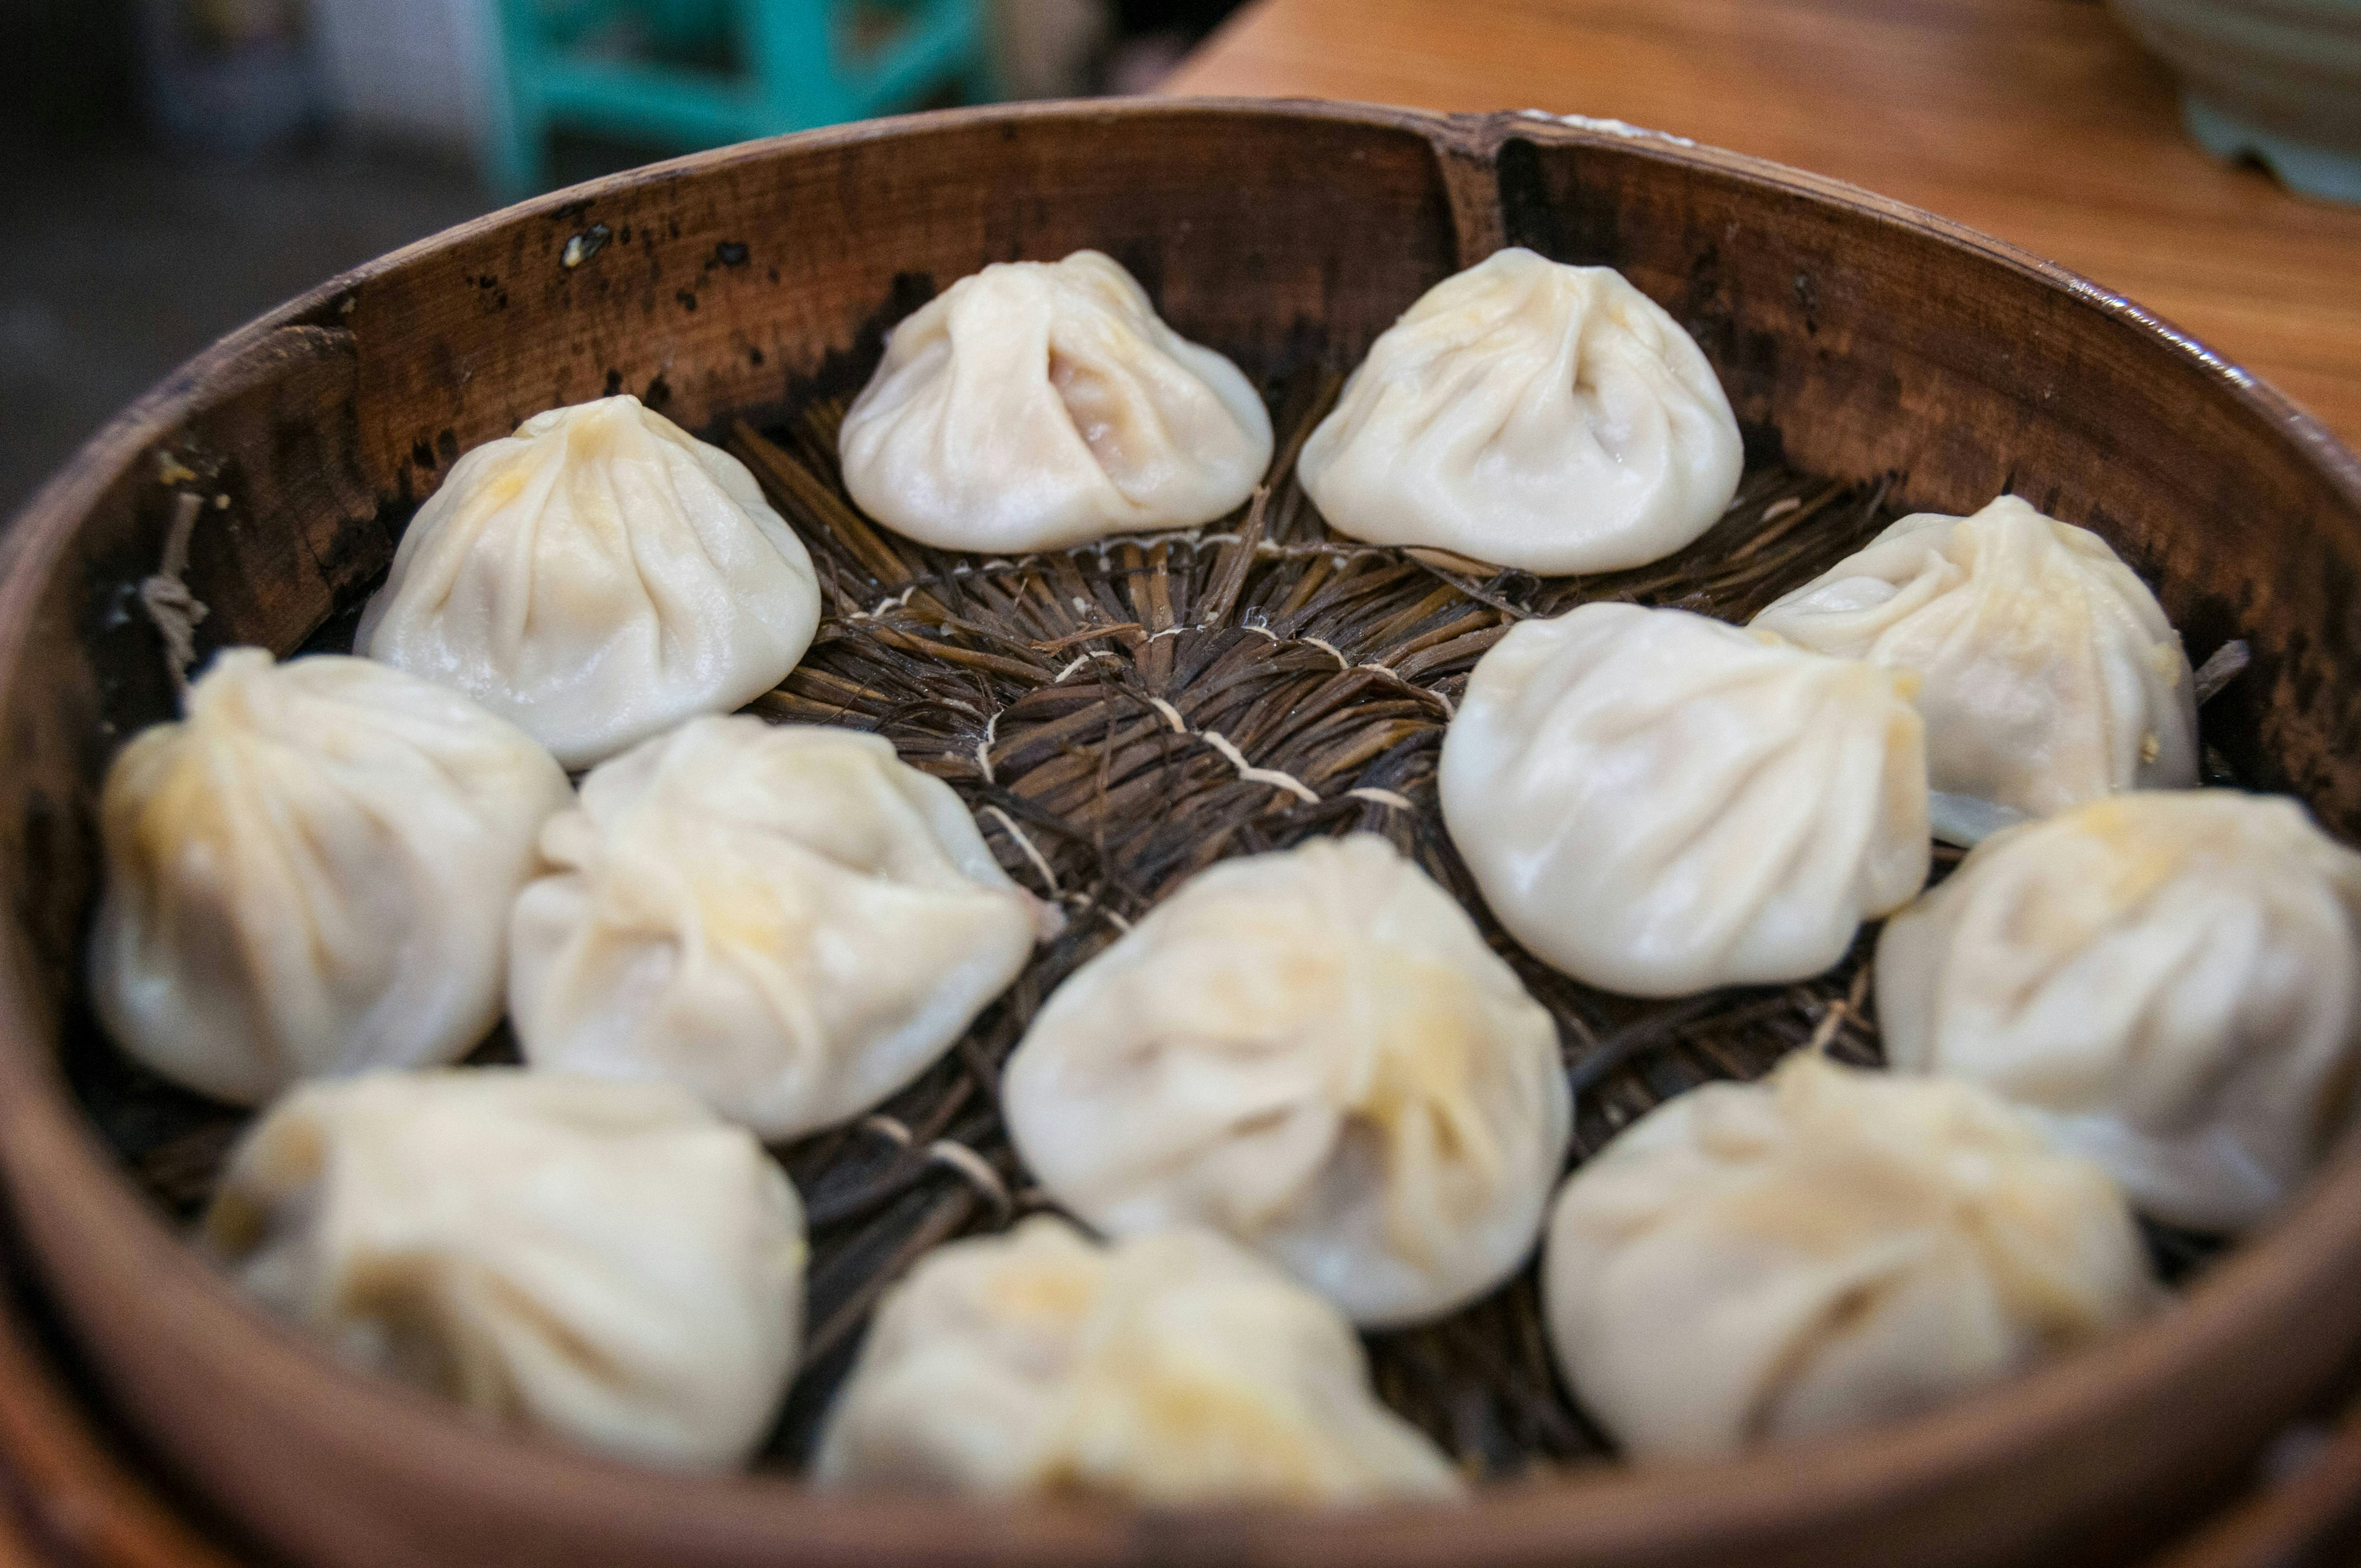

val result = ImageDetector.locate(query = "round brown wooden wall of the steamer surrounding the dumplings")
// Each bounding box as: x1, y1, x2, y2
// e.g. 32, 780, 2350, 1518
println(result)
0, 101, 2361, 1568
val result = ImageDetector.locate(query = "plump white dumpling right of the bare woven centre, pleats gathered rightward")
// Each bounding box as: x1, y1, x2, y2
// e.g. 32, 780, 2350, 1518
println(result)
1440, 604, 1929, 997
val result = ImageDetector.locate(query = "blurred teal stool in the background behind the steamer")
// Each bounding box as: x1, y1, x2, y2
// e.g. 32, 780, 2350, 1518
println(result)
481, 0, 994, 200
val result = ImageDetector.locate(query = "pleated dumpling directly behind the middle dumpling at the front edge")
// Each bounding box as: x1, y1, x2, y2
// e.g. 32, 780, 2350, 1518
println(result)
1001, 834, 1572, 1324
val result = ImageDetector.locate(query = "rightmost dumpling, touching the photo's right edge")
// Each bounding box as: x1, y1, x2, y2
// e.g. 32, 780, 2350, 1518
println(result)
1877, 789, 2361, 1230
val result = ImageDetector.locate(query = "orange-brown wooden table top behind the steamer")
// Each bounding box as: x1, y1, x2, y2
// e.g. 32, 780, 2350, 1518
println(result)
1164, 0, 2361, 446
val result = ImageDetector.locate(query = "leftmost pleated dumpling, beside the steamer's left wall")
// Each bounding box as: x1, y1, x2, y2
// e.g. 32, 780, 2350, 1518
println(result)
90, 647, 571, 1105
